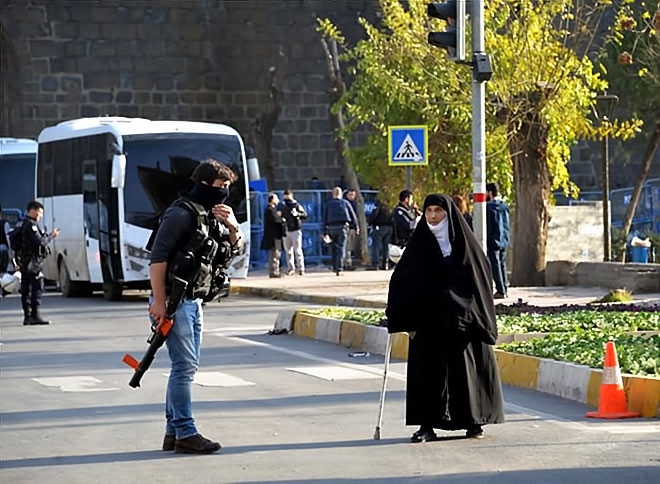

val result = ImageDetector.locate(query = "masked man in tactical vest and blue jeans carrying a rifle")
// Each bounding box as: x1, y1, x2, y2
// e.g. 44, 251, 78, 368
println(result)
149, 159, 243, 454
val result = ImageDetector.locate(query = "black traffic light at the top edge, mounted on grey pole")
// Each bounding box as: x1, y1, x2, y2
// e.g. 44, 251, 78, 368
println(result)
426, 0, 466, 61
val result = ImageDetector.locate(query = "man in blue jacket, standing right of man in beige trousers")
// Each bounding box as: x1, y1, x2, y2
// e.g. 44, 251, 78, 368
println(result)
323, 187, 360, 276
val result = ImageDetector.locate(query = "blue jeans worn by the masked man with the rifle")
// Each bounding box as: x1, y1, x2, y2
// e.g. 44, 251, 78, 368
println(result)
153, 299, 204, 439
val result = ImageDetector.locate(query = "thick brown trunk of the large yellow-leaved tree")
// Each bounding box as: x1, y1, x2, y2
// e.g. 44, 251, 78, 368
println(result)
509, 111, 551, 286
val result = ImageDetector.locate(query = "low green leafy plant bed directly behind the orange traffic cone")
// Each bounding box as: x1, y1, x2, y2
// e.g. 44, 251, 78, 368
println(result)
498, 330, 660, 377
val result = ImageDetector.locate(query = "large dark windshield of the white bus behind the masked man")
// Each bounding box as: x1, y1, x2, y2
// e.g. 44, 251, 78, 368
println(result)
124, 133, 247, 229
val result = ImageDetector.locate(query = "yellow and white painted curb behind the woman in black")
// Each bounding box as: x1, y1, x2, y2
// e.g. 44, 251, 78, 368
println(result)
275, 310, 660, 418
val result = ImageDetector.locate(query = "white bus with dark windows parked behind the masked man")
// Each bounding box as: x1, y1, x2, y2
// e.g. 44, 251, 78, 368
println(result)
37, 117, 250, 300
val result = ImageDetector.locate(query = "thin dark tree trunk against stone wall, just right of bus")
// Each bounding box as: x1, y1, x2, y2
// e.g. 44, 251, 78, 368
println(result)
254, 66, 282, 190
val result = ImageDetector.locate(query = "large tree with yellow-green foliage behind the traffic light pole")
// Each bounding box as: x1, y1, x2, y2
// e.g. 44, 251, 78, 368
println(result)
321, 0, 639, 286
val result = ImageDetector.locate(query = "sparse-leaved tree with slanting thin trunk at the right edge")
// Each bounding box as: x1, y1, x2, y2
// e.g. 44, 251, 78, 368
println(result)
601, 2, 660, 262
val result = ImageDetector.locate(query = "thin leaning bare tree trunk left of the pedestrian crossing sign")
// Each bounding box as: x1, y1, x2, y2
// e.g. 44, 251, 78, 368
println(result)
321, 37, 370, 265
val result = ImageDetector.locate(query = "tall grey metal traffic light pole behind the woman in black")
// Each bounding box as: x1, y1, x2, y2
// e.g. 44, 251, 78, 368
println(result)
472, 0, 486, 252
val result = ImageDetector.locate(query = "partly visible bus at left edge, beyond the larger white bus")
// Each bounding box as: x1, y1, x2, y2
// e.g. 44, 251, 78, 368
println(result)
0, 138, 37, 218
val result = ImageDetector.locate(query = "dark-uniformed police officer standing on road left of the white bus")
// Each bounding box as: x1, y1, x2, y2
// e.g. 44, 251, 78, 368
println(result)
16, 200, 60, 325
